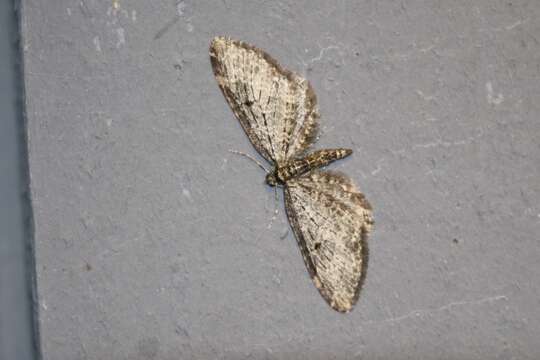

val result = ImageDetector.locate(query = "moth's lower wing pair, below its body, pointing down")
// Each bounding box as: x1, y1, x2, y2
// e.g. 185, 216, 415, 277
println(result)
285, 171, 373, 312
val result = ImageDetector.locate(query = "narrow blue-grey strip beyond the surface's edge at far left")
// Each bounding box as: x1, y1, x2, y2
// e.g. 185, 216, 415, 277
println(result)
0, 1, 37, 360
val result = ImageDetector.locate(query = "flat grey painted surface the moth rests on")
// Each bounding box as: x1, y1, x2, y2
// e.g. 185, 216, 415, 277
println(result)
23, 0, 540, 359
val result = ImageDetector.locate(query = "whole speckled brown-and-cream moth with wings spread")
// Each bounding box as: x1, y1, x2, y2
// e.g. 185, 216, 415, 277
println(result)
210, 37, 373, 312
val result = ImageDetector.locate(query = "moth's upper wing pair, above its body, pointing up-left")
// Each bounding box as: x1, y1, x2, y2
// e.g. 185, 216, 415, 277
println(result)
210, 37, 319, 163
